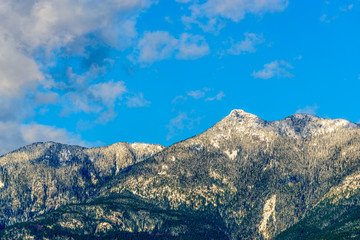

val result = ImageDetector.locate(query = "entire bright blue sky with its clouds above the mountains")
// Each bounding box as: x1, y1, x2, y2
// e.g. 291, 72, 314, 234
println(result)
0, 0, 360, 153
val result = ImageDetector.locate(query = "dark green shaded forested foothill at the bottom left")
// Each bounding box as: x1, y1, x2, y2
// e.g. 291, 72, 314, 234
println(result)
0, 193, 227, 239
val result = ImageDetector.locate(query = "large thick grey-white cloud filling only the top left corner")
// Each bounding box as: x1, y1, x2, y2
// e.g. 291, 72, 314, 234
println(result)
0, 0, 153, 117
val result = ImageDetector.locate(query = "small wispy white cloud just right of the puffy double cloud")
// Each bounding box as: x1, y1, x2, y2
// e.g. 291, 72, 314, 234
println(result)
227, 33, 265, 55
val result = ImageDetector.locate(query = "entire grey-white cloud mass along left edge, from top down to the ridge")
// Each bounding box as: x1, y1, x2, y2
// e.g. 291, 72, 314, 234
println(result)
0, 0, 156, 151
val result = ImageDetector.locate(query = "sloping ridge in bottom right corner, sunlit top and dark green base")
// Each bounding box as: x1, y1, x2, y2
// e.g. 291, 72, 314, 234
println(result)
276, 171, 360, 240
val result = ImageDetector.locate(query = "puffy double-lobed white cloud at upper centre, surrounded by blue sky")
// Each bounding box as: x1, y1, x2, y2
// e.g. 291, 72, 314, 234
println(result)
129, 31, 210, 63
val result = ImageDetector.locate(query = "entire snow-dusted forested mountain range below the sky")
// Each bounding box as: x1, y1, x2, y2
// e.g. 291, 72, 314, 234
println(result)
0, 110, 360, 239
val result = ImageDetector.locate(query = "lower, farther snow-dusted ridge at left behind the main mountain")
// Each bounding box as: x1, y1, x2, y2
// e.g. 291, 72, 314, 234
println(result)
0, 142, 163, 228
